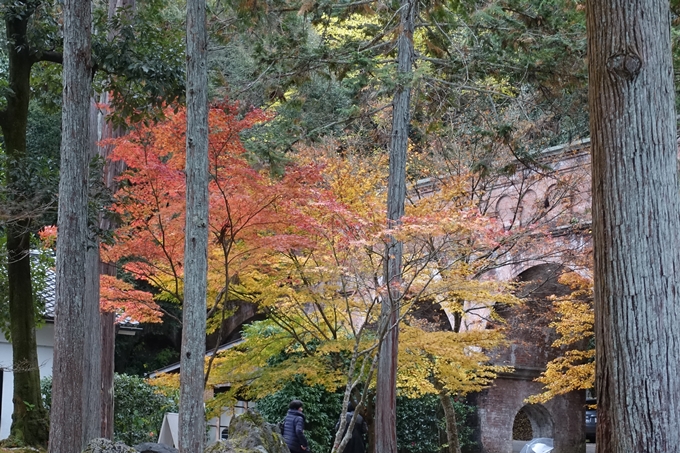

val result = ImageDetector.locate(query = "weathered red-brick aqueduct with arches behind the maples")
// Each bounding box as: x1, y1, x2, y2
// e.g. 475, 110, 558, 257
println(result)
215, 140, 591, 453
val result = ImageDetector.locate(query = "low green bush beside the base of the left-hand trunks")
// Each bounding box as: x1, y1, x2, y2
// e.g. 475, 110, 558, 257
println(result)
41, 374, 179, 445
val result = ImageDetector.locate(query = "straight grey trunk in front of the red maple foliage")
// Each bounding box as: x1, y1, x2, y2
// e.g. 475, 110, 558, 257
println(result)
179, 0, 208, 453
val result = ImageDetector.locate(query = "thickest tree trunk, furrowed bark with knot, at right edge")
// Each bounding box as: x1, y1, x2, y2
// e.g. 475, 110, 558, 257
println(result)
587, 0, 680, 453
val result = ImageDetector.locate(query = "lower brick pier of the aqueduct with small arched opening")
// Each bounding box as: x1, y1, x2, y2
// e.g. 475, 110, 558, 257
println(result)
473, 262, 585, 453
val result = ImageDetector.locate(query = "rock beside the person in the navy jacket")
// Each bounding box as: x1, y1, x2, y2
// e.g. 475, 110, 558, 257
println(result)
205, 410, 290, 453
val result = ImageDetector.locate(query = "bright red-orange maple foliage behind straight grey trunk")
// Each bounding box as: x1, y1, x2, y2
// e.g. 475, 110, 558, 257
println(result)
103, 103, 308, 322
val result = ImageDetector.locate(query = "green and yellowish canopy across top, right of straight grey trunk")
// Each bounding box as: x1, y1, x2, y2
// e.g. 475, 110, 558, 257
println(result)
213, 0, 588, 169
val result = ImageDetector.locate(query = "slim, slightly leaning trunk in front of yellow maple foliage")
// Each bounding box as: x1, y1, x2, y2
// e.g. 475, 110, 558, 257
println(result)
374, 0, 415, 453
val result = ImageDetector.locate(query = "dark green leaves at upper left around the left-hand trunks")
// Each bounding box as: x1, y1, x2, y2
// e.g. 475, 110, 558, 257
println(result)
0, 0, 185, 125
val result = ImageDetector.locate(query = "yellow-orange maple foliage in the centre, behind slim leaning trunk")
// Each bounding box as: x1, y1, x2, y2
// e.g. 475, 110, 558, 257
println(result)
203, 149, 517, 408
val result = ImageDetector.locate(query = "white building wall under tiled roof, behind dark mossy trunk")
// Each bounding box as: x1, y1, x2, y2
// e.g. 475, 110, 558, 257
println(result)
0, 323, 54, 439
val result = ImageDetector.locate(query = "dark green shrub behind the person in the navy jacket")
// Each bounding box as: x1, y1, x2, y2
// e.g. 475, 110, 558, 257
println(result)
257, 377, 342, 452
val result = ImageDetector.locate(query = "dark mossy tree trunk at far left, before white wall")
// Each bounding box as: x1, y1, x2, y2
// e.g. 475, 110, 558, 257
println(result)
0, 5, 49, 446
